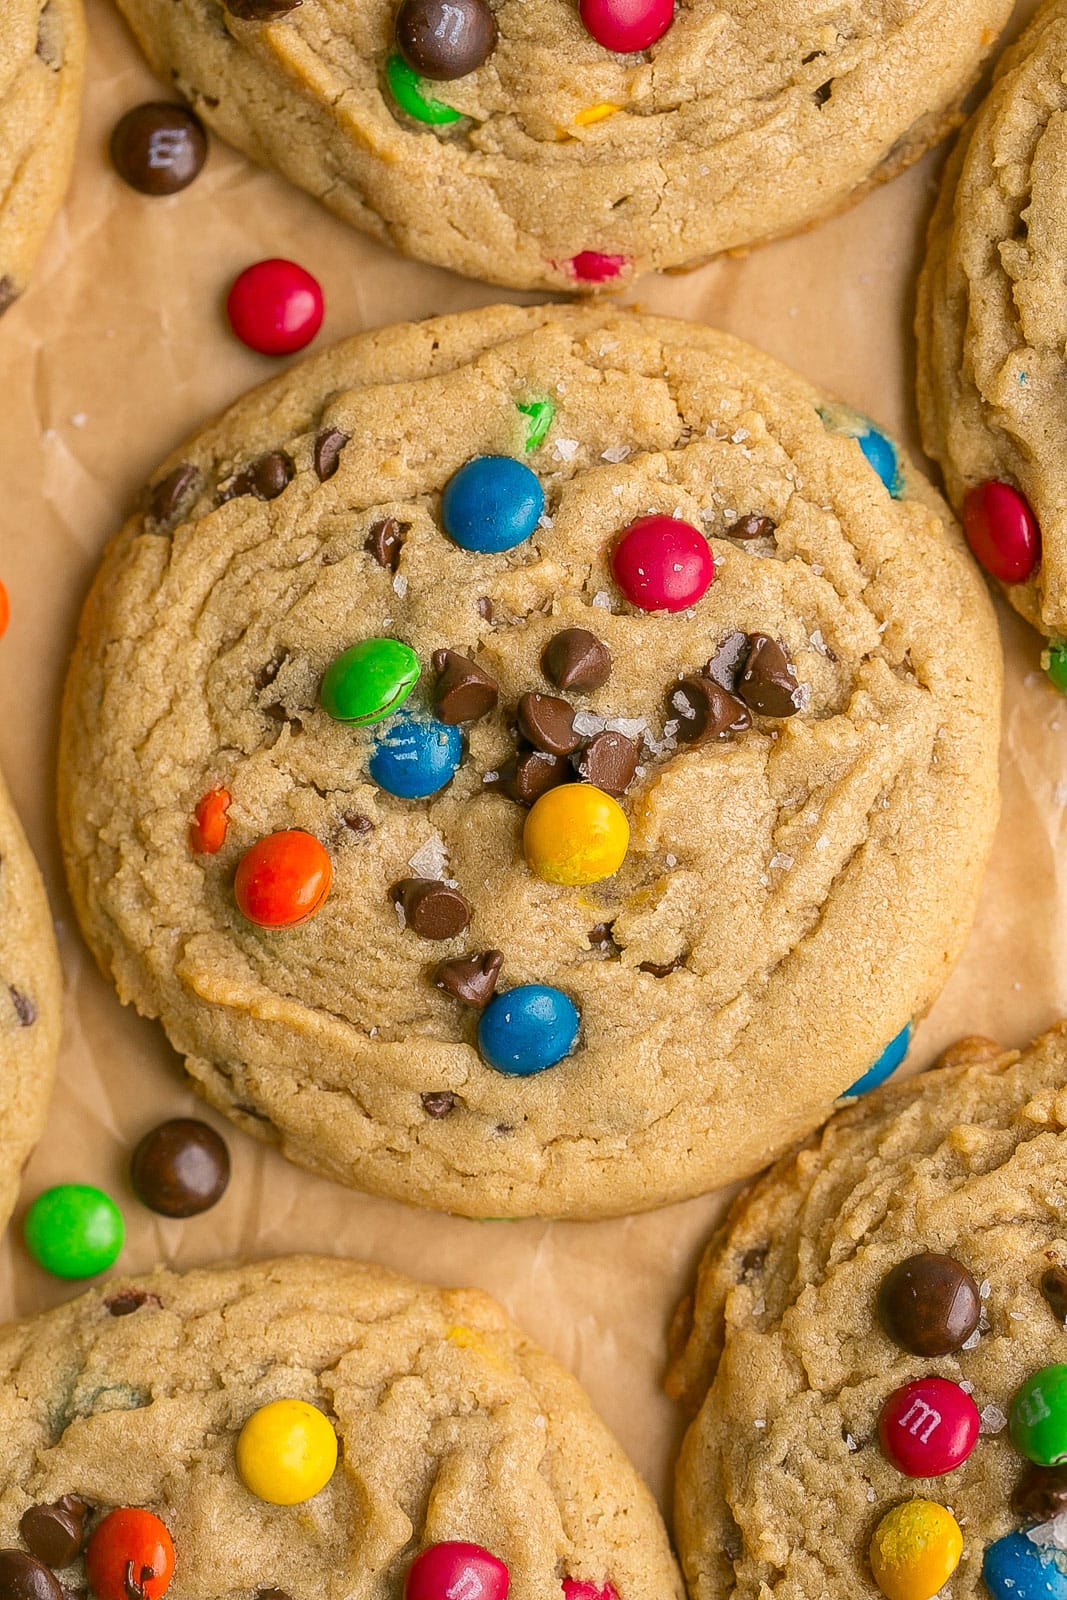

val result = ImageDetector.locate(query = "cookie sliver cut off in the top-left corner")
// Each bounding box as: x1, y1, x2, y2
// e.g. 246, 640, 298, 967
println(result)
0, 0, 85, 314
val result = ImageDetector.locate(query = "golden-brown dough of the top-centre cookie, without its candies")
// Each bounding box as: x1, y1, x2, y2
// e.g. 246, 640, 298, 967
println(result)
120, 0, 1011, 290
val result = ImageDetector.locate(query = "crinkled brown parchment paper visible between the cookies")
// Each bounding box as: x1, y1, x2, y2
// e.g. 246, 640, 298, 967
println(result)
0, 0, 1067, 1523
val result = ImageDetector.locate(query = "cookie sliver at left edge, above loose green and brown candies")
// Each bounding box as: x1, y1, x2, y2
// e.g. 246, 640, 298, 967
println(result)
0, 761, 62, 1227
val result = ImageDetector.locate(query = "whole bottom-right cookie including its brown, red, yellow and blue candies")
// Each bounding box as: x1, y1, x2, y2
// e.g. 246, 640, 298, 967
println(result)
669, 1024, 1067, 1600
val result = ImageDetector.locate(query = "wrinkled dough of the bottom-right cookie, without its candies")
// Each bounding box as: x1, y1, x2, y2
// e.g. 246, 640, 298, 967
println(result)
669, 1024, 1067, 1600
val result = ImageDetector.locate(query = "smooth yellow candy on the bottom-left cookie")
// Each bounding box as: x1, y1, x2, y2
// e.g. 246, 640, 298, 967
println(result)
237, 1400, 338, 1506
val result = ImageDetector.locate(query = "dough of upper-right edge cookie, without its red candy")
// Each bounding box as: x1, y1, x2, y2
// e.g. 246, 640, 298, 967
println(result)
917, 0, 1067, 637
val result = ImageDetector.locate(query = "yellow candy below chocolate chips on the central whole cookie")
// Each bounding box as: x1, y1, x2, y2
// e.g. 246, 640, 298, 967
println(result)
523, 784, 630, 883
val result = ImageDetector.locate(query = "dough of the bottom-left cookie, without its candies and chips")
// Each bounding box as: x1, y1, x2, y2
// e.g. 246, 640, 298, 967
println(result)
0, 1256, 681, 1600
